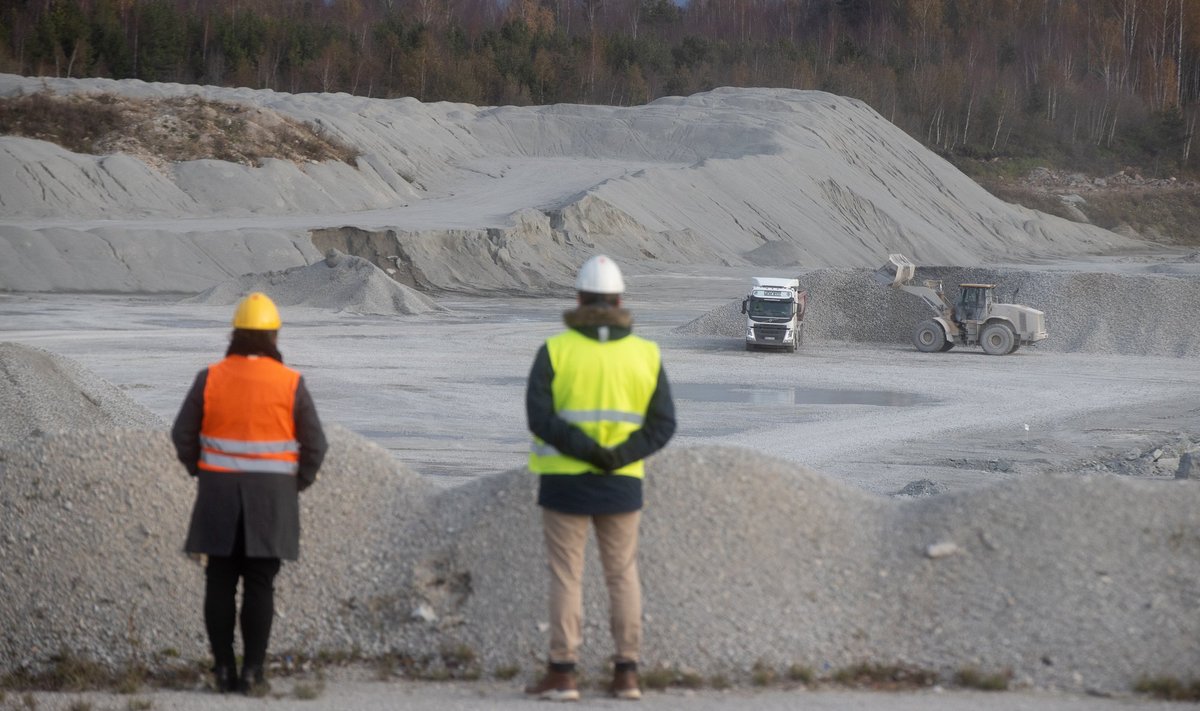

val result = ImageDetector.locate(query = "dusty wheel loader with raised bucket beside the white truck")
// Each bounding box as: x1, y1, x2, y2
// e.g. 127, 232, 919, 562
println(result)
875, 255, 1046, 356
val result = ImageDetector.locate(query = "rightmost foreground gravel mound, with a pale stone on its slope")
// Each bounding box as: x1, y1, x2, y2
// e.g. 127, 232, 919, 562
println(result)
875, 474, 1200, 689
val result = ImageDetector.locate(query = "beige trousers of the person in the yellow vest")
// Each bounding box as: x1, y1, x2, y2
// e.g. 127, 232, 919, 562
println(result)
542, 508, 642, 663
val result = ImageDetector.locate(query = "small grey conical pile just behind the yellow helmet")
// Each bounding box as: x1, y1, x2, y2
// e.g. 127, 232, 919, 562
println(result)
186, 250, 445, 316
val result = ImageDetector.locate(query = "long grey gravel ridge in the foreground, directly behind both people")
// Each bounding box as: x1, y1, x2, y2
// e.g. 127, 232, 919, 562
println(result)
0, 348, 1200, 691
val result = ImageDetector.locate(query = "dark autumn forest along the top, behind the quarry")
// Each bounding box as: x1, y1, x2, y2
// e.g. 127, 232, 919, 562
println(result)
0, 0, 1200, 177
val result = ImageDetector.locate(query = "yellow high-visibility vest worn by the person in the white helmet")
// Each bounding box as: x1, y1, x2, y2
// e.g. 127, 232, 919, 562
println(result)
529, 329, 661, 478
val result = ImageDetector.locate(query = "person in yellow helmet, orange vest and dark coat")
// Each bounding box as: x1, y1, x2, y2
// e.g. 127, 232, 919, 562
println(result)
170, 292, 326, 695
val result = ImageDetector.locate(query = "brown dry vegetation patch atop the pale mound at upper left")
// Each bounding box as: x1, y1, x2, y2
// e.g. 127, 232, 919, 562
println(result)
0, 91, 359, 168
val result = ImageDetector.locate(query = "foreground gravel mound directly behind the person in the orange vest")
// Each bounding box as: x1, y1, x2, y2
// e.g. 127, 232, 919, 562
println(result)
0, 426, 426, 669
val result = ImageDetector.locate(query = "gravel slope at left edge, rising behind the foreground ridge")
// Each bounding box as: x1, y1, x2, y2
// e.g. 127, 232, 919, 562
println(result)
0, 342, 166, 448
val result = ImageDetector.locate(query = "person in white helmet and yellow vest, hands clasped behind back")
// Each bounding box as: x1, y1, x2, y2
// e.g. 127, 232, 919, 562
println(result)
526, 255, 676, 701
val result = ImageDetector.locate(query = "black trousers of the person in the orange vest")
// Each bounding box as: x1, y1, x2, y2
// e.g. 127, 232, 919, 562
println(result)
204, 521, 281, 668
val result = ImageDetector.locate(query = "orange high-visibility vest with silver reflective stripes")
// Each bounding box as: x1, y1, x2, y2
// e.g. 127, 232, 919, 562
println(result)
198, 356, 300, 476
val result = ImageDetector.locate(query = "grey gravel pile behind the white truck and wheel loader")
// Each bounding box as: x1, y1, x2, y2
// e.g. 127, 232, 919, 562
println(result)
676, 267, 1200, 357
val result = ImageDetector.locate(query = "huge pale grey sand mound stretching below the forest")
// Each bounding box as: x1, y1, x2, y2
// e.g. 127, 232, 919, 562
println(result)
0, 74, 1146, 293
